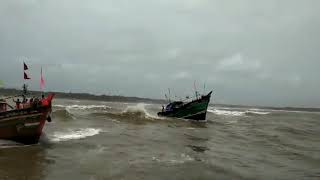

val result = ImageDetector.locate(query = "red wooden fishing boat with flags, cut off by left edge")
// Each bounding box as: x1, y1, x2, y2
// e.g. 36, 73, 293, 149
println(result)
0, 62, 54, 144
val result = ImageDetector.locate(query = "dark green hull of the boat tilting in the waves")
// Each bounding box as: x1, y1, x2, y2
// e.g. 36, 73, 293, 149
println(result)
158, 92, 211, 121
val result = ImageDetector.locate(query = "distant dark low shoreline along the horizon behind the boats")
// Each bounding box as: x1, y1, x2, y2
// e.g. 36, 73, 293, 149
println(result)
0, 88, 320, 112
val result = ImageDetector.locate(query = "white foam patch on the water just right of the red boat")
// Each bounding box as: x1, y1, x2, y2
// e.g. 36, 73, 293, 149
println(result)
50, 128, 101, 142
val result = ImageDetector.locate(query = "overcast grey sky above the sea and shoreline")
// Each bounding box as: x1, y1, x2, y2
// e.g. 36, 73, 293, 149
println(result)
0, 0, 320, 107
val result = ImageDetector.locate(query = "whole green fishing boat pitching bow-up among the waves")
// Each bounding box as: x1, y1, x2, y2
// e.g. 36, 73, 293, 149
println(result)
158, 91, 212, 121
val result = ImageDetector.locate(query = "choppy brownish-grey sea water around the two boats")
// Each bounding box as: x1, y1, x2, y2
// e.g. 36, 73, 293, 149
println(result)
0, 99, 320, 180
